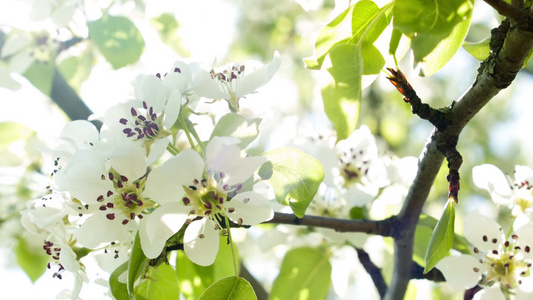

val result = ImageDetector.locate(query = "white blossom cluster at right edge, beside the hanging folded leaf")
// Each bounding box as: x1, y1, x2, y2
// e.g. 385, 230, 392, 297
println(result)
437, 164, 533, 299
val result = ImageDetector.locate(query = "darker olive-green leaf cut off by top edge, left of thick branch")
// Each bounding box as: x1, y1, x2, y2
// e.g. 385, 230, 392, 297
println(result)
393, 0, 473, 62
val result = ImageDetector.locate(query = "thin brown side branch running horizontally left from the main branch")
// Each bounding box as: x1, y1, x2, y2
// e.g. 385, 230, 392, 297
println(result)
265, 212, 396, 236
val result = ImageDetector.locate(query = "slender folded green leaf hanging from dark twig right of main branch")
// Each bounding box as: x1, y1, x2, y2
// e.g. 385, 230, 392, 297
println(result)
424, 200, 455, 274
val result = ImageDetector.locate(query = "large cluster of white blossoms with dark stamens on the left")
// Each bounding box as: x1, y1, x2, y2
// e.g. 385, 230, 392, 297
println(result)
22, 52, 280, 299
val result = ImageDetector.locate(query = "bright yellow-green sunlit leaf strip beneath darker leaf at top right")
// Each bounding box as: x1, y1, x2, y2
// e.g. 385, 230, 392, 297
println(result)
424, 15, 472, 76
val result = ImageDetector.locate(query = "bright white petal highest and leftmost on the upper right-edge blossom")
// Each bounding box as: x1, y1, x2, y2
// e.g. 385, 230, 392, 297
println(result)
472, 164, 513, 205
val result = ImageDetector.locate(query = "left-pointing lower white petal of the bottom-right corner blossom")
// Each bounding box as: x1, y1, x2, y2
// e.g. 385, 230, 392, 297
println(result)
437, 255, 486, 290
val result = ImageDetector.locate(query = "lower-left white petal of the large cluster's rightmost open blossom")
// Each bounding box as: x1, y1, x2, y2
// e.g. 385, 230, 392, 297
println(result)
139, 203, 190, 258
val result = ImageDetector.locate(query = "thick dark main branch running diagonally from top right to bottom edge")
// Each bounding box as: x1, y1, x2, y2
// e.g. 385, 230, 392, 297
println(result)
385, 14, 533, 299
